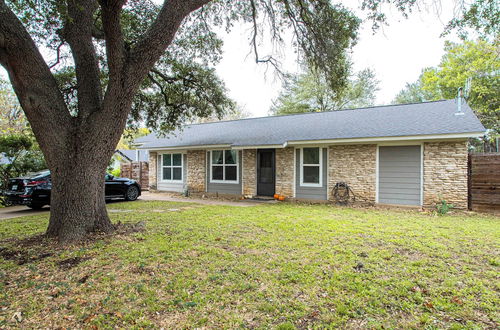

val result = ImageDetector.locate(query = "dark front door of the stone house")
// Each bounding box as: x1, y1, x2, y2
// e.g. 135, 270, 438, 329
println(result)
257, 149, 276, 196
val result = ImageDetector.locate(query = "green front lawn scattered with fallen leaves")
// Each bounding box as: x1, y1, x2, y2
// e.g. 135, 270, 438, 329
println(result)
0, 201, 500, 329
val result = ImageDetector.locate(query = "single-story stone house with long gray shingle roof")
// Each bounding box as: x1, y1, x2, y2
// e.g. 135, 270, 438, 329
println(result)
135, 100, 485, 208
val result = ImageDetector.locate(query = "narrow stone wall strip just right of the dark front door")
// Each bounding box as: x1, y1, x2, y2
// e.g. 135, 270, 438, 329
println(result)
276, 147, 295, 198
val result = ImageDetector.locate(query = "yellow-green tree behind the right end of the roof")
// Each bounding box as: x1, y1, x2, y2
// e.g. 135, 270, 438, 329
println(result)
394, 39, 500, 133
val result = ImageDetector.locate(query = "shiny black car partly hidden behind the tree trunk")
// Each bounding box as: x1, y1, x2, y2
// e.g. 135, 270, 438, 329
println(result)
5, 170, 141, 209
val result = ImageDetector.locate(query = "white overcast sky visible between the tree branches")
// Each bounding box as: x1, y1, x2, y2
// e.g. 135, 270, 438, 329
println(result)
0, 0, 457, 117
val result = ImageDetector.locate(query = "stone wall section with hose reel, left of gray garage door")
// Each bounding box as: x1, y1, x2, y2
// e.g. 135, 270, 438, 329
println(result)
328, 144, 377, 203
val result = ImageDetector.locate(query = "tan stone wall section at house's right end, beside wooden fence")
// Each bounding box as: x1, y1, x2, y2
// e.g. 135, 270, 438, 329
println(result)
424, 141, 468, 208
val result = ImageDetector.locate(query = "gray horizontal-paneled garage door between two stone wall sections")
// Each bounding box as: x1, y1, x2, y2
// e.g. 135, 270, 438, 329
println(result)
378, 146, 422, 205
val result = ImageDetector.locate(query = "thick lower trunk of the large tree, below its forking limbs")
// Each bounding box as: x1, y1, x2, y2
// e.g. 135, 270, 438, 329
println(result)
47, 146, 114, 243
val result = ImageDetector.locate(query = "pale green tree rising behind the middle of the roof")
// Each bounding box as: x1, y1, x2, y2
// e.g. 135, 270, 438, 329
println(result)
271, 69, 379, 115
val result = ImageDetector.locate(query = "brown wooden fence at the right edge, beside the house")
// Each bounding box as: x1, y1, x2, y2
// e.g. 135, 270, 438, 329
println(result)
469, 153, 500, 213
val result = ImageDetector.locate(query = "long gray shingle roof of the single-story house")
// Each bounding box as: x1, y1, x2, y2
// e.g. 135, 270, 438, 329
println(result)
136, 100, 485, 149
